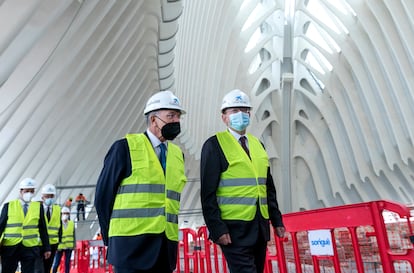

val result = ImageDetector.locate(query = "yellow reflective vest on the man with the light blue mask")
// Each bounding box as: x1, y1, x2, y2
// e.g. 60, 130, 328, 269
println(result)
216, 131, 269, 221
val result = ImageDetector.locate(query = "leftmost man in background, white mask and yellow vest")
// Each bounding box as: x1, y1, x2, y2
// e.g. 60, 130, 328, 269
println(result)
0, 178, 51, 273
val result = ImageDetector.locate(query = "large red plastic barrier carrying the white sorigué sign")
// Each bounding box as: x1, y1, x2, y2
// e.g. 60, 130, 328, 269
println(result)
265, 200, 414, 273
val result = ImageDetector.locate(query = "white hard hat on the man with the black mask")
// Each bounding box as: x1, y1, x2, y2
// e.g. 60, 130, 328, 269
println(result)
144, 90, 185, 115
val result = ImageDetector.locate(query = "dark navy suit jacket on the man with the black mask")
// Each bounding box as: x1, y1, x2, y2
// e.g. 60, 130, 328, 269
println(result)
95, 134, 178, 270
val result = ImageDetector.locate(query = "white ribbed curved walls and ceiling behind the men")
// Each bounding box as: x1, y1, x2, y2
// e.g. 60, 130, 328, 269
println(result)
0, 0, 414, 219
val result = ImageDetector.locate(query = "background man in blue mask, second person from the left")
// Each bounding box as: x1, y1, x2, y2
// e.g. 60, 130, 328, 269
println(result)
41, 184, 62, 273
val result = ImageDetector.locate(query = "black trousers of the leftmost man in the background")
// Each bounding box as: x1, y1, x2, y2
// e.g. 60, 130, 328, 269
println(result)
0, 244, 40, 273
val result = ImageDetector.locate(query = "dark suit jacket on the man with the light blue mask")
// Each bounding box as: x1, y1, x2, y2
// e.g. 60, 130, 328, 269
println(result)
200, 133, 283, 246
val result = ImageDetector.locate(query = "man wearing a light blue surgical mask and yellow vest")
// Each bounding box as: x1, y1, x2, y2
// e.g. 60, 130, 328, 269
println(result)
200, 89, 285, 273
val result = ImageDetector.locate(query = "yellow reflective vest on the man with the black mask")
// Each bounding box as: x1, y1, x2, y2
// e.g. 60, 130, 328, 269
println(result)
109, 134, 186, 241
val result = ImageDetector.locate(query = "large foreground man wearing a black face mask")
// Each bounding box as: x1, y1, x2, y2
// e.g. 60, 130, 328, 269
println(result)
95, 91, 187, 273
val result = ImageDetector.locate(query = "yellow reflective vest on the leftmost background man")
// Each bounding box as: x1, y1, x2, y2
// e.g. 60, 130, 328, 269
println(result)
2, 200, 41, 247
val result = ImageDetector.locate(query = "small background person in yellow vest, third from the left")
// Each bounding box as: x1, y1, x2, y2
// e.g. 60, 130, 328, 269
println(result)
52, 207, 76, 273
